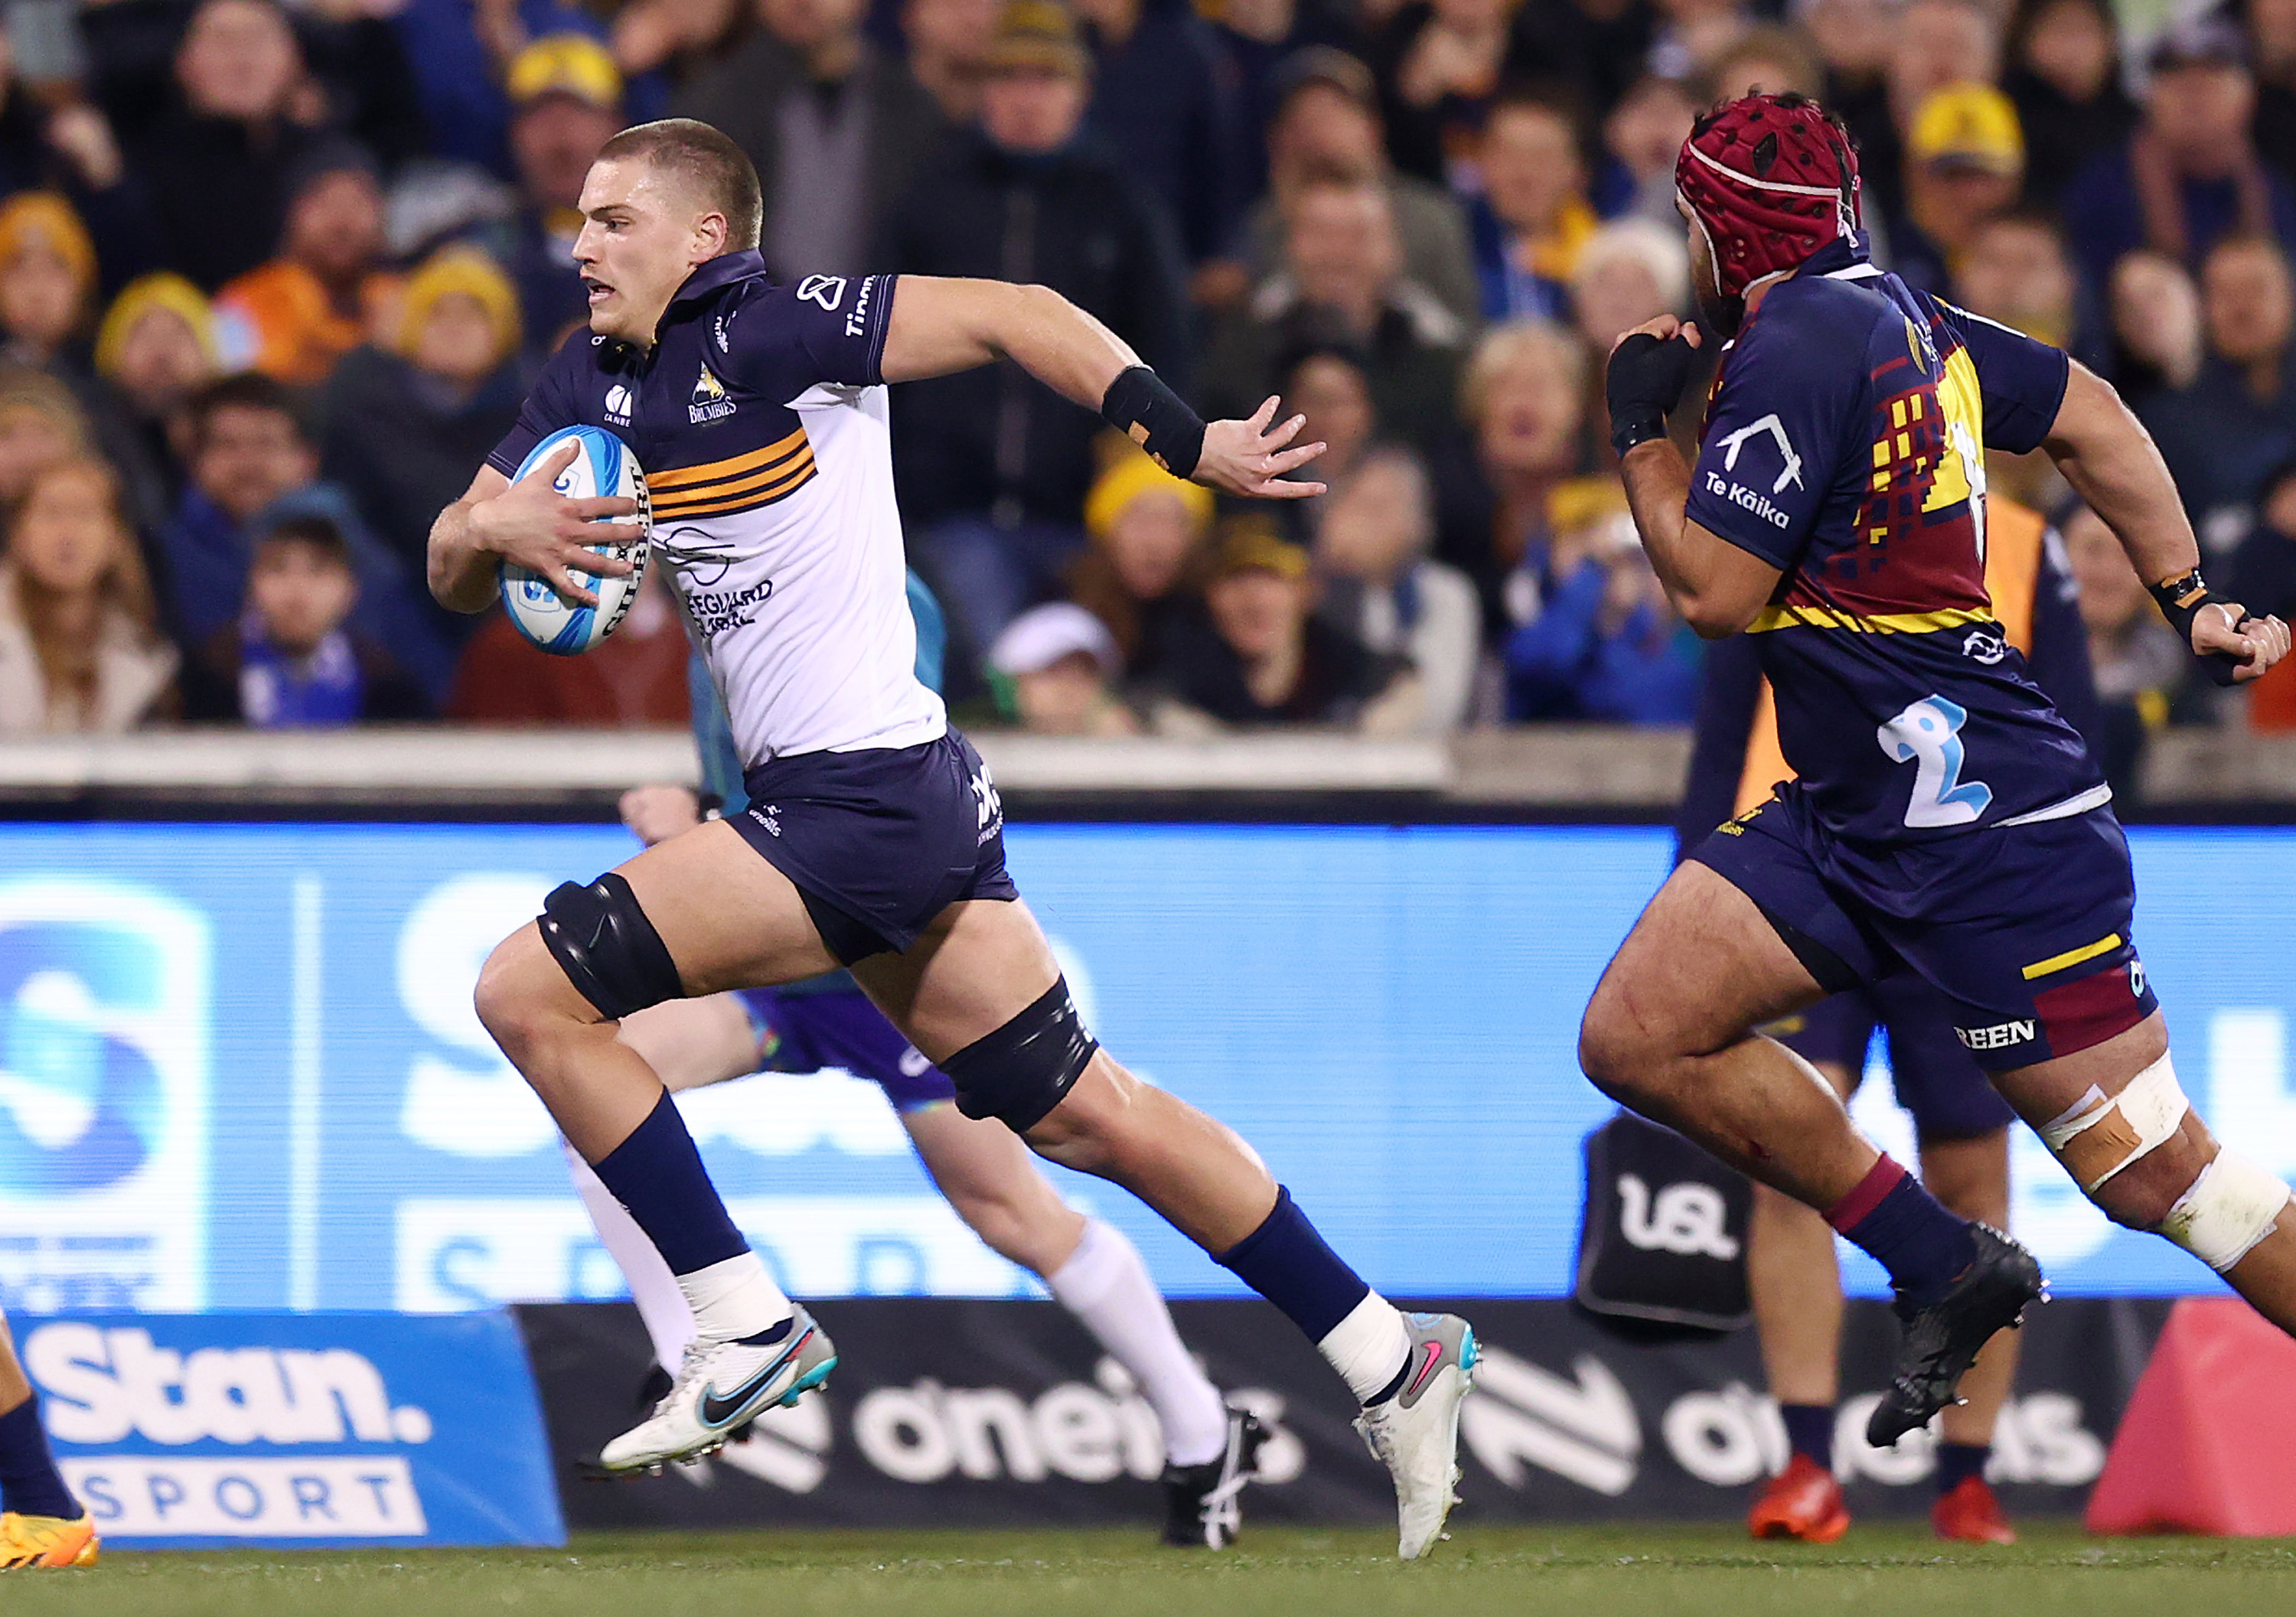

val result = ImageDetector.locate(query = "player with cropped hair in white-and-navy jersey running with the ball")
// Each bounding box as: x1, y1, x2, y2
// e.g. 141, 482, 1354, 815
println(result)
429, 119, 1476, 1560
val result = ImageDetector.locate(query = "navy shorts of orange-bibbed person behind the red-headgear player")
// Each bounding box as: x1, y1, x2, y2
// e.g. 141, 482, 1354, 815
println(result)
1761, 972, 2016, 1142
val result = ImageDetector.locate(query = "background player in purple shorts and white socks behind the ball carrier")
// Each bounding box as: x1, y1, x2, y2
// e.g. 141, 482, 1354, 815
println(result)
567, 588, 1265, 1550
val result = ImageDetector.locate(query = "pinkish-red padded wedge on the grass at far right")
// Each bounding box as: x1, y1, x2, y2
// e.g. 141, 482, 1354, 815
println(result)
2085, 1298, 2296, 1539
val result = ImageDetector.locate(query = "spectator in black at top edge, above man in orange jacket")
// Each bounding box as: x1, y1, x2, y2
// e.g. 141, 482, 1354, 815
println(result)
129, 0, 319, 292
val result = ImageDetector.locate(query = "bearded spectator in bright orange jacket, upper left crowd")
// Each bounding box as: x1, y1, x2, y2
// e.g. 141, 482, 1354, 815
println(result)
216, 140, 400, 388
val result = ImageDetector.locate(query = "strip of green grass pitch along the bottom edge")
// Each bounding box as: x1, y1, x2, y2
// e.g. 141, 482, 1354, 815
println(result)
0, 1523, 2296, 1617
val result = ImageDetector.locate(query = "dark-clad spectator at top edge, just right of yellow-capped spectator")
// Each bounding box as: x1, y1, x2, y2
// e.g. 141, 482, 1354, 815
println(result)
2002, 0, 2138, 207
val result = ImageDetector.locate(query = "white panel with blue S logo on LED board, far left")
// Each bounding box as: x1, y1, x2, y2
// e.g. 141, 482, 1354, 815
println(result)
0, 878, 211, 1314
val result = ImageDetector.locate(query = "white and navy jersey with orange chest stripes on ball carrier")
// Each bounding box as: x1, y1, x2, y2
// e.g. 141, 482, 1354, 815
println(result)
487, 253, 948, 769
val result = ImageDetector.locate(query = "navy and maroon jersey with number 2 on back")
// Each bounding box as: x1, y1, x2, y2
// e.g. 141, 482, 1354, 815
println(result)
1688, 241, 2110, 841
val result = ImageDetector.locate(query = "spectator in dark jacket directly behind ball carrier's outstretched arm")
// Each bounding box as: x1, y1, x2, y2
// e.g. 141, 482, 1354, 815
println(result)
882, 0, 1194, 657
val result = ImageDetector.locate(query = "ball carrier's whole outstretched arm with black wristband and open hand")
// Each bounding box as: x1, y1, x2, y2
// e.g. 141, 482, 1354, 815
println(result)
882, 275, 1322, 500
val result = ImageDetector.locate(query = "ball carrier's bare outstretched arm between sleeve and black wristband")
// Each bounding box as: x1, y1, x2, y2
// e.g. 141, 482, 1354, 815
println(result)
884, 275, 1141, 409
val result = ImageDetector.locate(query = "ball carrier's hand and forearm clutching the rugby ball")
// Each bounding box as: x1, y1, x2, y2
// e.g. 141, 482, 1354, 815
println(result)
429, 443, 645, 611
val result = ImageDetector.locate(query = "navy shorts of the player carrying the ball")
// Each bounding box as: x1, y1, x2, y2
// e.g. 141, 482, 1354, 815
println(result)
730, 730, 1019, 965
